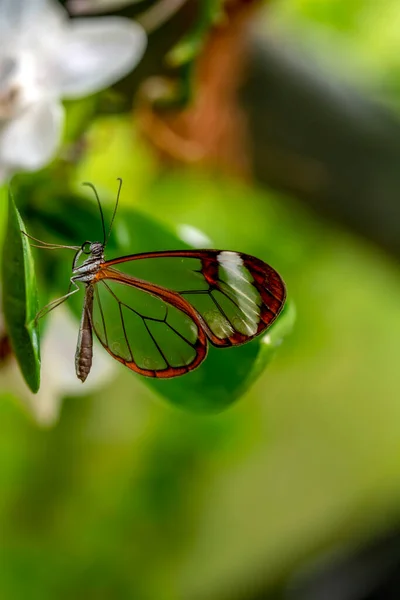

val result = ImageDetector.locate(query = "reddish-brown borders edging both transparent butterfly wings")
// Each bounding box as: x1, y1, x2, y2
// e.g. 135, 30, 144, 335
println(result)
93, 250, 286, 378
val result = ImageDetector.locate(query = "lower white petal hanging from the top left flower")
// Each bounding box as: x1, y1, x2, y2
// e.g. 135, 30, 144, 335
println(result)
0, 100, 64, 171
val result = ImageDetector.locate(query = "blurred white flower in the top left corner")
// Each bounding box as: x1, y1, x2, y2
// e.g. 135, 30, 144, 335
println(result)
0, 0, 146, 182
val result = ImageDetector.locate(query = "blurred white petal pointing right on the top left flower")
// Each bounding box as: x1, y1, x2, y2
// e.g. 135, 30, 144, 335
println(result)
58, 17, 146, 98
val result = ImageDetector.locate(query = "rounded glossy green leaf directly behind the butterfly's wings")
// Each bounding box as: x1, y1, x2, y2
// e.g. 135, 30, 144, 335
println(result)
28, 195, 294, 411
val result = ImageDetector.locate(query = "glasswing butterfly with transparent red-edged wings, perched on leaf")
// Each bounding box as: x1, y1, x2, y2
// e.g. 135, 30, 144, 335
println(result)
28, 180, 286, 382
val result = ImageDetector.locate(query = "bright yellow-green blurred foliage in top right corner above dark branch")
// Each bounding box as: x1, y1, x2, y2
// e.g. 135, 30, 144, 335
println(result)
268, 0, 400, 98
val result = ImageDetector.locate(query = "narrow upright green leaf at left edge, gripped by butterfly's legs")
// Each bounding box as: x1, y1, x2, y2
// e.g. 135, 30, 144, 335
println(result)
2, 192, 40, 393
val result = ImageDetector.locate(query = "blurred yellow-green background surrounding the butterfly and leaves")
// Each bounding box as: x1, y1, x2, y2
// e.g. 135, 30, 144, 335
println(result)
0, 0, 400, 600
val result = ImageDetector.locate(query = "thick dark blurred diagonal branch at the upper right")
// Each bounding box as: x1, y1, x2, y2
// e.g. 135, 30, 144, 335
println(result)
240, 39, 400, 257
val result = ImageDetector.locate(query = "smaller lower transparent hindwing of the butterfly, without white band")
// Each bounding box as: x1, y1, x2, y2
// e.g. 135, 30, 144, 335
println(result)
92, 279, 207, 378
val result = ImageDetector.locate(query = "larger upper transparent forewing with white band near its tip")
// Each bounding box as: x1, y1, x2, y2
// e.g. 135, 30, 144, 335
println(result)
97, 250, 286, 347
